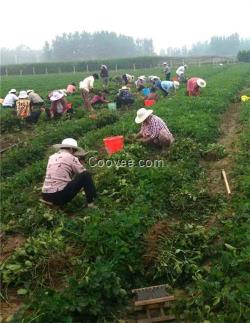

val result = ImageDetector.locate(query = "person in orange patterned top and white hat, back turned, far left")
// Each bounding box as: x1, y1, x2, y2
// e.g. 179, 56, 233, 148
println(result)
16, 91, 41, 123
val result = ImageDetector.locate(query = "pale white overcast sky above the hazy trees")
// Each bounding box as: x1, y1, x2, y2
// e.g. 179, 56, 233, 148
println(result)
0, 0, 250, 52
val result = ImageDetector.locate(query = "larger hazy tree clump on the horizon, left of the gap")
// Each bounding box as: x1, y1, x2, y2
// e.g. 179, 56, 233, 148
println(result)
1, 31, 156, 65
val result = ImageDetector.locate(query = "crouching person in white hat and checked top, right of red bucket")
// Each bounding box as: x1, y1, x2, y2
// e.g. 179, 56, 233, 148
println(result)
135, 108, 174, 149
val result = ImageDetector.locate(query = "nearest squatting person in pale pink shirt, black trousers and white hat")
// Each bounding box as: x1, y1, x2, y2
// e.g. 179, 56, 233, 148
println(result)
42, 138, 96, 207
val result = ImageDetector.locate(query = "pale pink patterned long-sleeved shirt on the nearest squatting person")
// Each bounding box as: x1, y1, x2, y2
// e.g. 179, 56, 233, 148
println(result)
42, 149, 85, 193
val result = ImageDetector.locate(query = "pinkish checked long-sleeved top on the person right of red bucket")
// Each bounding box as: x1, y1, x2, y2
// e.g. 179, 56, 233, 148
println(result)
140, 115, 172, 139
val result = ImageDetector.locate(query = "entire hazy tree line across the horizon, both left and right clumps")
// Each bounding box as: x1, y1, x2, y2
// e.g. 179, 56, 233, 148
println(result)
1, 31, 250, 65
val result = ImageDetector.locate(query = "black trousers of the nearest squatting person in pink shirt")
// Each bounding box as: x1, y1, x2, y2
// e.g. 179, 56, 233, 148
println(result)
42, 171, 96, 205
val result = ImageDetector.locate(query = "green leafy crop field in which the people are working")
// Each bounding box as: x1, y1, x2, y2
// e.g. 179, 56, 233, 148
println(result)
0, 64, 250, 323
